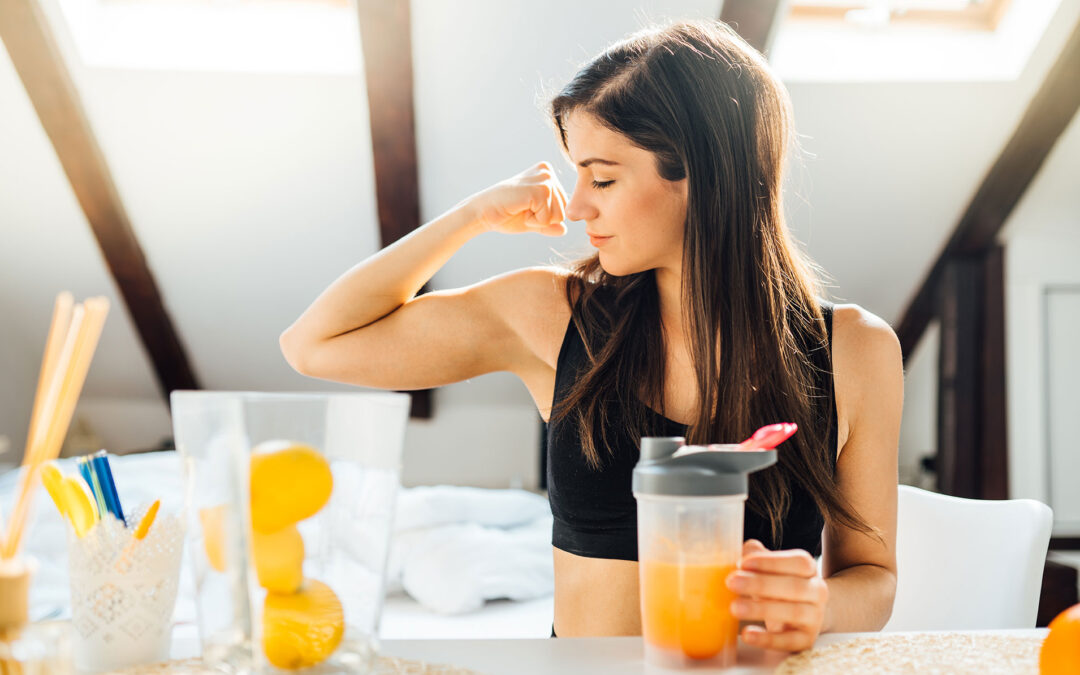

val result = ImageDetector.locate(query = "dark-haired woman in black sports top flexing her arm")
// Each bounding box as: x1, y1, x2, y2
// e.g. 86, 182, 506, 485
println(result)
281, 22, 903, 651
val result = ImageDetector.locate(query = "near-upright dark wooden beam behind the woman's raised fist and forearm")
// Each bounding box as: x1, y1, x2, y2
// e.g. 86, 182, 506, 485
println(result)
356, 0, 432, 418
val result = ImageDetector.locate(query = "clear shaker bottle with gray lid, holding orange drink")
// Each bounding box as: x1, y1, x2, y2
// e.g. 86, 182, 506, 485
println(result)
633, 437, 777, 669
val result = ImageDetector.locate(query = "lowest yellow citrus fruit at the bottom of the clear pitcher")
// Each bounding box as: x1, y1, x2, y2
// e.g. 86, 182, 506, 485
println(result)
262, 579, 345, 670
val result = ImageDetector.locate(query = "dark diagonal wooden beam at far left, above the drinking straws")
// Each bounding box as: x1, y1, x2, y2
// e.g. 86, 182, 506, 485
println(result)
0, 0, 200, 401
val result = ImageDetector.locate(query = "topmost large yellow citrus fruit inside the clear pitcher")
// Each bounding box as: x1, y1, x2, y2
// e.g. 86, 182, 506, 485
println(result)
251, 442, 334, 534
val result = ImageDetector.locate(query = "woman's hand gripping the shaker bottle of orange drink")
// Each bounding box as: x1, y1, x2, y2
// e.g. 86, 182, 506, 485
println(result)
727, 539, 828, 651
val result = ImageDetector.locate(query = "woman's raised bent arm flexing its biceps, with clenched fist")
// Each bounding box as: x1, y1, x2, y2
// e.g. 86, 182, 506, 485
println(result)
280, 163, 566, 389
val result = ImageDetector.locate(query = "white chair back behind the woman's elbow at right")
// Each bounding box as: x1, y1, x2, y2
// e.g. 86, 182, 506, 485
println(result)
882, 485, 1053, 631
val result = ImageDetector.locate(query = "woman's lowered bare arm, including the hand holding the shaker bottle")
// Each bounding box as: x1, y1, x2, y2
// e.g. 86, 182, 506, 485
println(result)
728, 306, 904, 651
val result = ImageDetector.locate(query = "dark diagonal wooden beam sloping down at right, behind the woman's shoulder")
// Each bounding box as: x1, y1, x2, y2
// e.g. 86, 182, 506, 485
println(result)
896, 25, 1080, 361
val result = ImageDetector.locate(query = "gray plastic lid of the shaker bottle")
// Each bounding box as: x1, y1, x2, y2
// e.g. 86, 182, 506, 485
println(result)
633, 436, 777, 497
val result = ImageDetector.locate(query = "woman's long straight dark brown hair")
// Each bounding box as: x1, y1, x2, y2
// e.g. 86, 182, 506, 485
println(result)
551, 22, 873, 545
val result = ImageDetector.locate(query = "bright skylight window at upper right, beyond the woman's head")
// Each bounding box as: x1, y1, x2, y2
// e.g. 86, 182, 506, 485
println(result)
769, 0, 1059, 82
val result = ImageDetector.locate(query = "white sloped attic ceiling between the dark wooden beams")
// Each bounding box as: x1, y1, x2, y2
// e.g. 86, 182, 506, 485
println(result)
0, 0, 1080, 462
